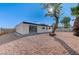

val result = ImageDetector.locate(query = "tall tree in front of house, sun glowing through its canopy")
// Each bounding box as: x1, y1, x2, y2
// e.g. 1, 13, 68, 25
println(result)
43, 3, 61, 33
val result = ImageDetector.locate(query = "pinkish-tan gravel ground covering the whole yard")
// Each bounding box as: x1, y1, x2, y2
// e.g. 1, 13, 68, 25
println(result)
0, 32, 79, 55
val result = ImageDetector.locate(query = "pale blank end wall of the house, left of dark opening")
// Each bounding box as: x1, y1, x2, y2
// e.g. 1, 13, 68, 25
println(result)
16, 23, 29, 34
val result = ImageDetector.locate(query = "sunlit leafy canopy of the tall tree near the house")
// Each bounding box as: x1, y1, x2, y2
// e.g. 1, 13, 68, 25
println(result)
42, 3, 61, 18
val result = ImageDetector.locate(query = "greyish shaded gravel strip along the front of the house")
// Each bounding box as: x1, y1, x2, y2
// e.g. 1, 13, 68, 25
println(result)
0, 32, 48, 45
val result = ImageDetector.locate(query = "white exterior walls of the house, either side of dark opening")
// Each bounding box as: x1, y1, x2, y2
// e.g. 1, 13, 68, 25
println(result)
16, 23, 52, 34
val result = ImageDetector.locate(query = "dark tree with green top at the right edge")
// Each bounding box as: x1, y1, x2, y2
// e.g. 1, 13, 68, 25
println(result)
71, 4, 79, 36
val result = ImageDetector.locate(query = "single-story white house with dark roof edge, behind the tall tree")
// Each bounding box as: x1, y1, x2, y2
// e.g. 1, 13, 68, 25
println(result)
16, 22, 52, 34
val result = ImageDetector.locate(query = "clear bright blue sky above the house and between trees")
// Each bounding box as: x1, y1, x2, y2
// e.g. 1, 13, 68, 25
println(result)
0, 3, 76, 28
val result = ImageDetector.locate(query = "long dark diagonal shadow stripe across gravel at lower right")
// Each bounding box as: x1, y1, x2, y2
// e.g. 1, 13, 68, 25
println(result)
54, 37, 79, 55
